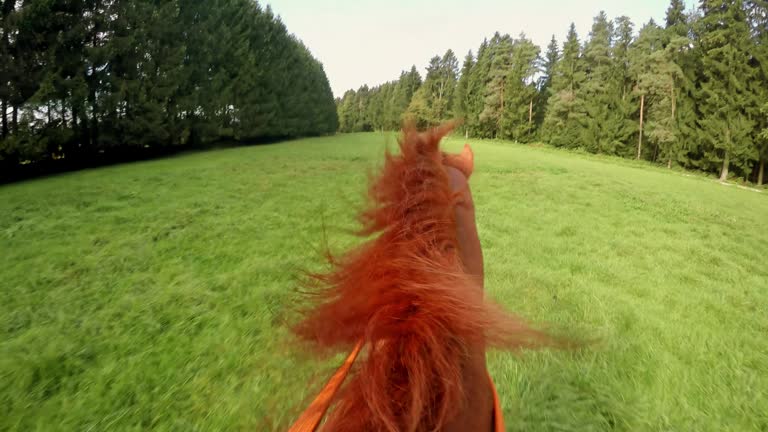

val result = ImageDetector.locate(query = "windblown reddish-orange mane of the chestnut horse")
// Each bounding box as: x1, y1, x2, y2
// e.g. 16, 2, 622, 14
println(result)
294, 125, 548, 432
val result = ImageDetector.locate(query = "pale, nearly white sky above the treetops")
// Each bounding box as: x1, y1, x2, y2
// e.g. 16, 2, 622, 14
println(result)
268, 0, 696, 96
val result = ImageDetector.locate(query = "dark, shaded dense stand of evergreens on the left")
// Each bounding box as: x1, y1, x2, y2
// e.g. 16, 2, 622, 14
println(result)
0, 0, 338, 178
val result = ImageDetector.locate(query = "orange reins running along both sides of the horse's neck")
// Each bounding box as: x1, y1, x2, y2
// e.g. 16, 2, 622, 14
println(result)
288, 340, 504, 432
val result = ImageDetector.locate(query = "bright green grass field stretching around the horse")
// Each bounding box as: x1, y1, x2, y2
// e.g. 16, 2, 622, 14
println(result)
0, 134, 768, 431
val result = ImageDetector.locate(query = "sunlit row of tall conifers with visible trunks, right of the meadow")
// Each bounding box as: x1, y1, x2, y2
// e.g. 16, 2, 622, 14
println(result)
336, 0, 768, 184
